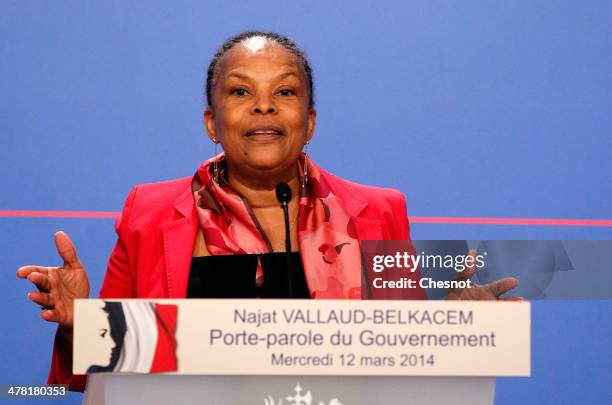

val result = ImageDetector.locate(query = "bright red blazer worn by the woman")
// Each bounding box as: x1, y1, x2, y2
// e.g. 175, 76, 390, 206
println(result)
48, 169, 426, 391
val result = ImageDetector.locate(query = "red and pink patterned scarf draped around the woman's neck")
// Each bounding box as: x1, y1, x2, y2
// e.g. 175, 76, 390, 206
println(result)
192, 153, 361, 299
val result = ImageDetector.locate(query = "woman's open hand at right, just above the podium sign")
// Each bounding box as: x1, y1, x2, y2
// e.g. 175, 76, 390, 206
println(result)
446, 250, 525, 301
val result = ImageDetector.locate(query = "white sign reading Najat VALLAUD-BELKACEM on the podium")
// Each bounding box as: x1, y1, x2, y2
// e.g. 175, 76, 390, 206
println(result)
73, 299, 531, 376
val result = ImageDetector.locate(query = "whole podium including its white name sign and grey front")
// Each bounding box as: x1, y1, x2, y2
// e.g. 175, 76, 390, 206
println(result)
73, 300, 531, 405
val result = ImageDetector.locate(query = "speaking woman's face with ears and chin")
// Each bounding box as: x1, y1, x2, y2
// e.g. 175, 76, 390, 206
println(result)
204, 37, 316, 180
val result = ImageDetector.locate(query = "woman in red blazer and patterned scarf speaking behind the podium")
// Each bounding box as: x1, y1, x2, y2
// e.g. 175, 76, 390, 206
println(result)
17, 32, 516, 390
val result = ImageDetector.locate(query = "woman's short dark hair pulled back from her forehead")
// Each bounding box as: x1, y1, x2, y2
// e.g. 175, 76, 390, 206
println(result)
206, 31, 314, 108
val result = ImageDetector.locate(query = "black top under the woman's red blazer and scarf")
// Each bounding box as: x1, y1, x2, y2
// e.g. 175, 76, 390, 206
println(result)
187, 252, 310, 298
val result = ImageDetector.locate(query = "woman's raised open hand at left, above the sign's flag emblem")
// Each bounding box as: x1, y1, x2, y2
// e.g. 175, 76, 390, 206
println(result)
17, 231, 89, 328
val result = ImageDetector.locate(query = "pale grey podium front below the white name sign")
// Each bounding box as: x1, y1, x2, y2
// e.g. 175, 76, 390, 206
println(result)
84, 373, 495, 405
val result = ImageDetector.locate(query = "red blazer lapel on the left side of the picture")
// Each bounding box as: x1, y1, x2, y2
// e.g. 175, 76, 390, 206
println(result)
162, 184, 198, 298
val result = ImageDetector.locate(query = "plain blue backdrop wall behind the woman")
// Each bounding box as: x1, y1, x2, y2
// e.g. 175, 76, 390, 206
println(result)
0, 1, 612, 404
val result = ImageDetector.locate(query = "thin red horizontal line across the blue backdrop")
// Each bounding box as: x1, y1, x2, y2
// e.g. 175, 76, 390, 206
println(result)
0, 210, 612, 227
